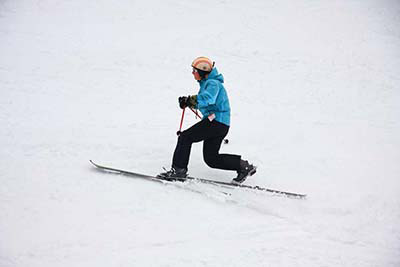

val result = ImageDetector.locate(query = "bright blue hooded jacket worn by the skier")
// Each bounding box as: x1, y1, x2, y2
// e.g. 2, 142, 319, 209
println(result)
196, 68, 231, 126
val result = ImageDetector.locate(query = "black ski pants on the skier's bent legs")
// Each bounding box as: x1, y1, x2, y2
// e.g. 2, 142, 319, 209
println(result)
172, 118, 241, 171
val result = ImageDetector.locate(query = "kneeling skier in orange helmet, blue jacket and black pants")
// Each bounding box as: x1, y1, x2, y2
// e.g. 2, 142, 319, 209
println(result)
158, 57, 256, 184
